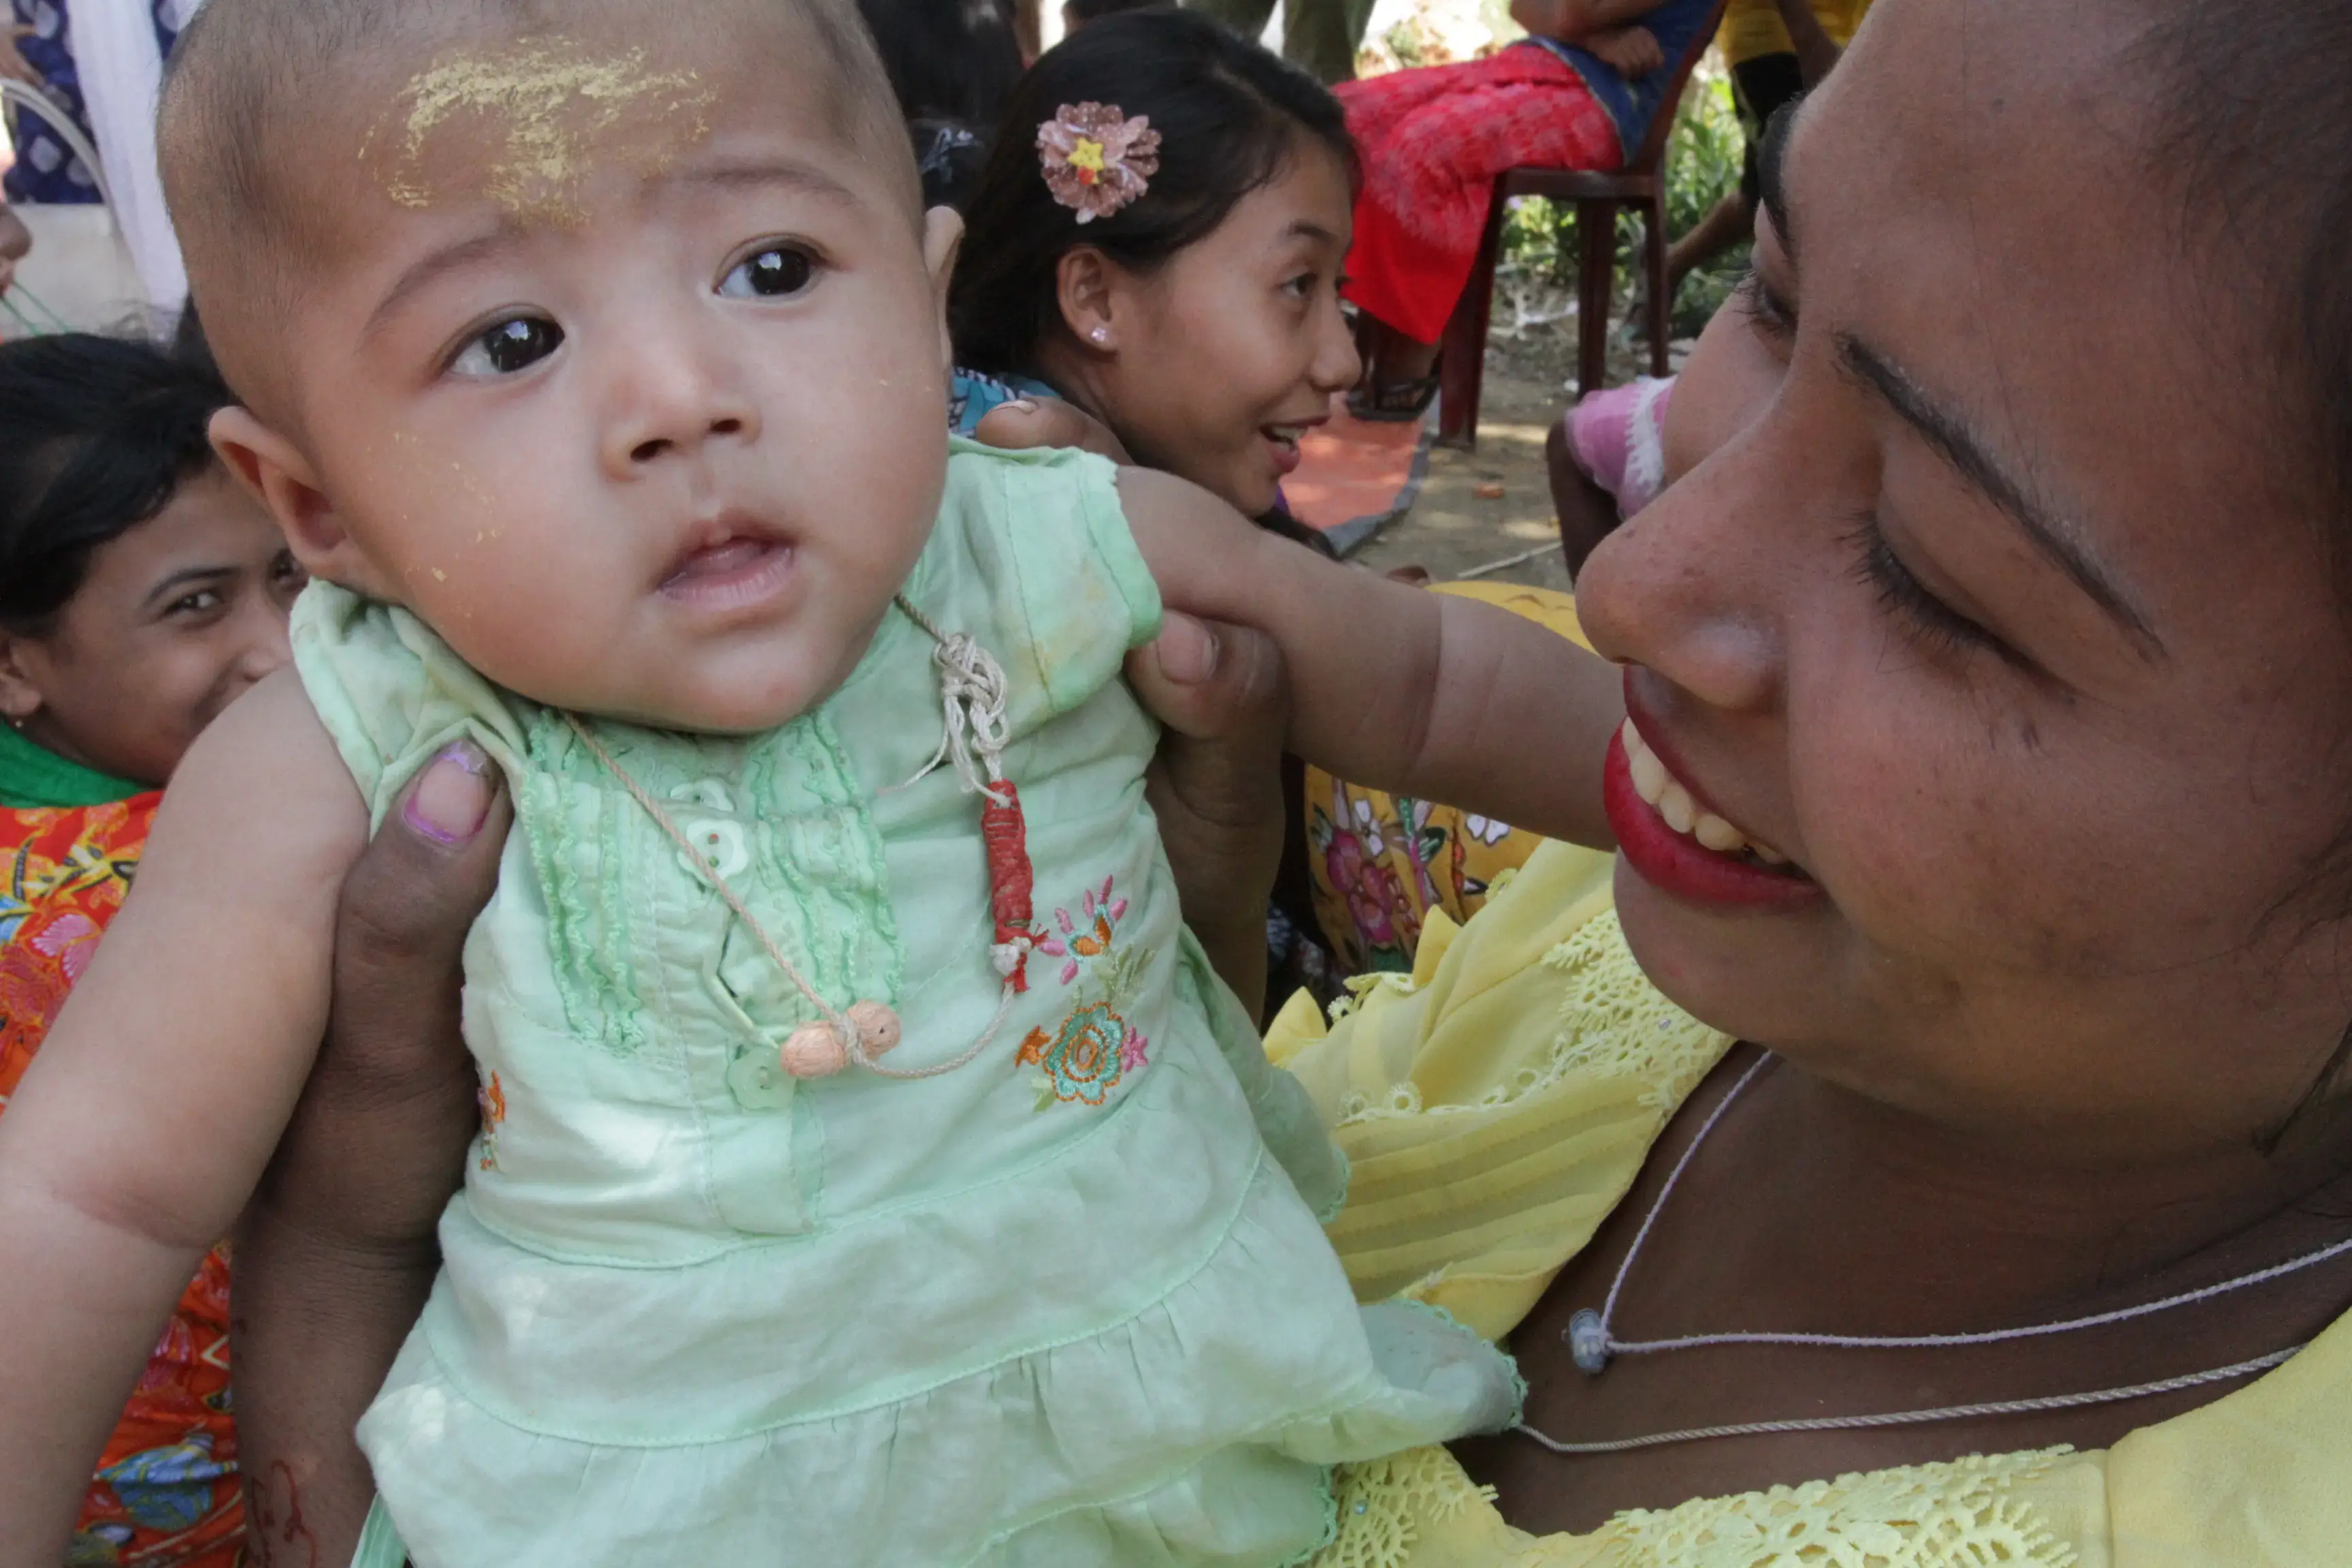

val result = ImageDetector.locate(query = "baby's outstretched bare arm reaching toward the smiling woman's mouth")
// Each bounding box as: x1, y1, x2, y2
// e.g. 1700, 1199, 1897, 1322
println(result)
1120, 468, 1625, 849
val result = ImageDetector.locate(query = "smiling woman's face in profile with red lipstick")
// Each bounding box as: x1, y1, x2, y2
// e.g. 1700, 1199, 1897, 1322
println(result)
1578, 0, 2352, 1161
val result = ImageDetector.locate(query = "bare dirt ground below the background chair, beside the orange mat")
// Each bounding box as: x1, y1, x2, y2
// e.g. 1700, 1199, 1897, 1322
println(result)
1350, 329, 1686, 588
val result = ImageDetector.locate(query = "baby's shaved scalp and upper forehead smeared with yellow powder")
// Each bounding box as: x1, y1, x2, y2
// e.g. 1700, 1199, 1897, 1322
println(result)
160, 0, 919, 430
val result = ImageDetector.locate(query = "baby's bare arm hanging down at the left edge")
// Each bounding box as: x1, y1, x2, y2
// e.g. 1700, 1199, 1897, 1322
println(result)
0, 670, 367, 1568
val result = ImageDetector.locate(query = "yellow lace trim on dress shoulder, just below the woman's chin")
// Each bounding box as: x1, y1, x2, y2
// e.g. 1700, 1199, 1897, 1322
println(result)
1331, 910, 1724, 1126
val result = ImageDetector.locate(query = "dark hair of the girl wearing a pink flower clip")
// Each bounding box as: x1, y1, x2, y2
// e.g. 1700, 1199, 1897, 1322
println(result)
948, 12, 1357, 376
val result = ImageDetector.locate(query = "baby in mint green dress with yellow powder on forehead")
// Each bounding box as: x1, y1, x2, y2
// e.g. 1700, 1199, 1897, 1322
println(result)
0, 0, 1614, 1568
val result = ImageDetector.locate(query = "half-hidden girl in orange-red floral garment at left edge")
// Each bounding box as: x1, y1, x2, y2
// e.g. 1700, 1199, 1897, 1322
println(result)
0, 336, 304, 1568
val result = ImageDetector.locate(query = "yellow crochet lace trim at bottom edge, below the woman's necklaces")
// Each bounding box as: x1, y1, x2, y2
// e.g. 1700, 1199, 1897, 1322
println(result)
1599, 1448, 2077, 1568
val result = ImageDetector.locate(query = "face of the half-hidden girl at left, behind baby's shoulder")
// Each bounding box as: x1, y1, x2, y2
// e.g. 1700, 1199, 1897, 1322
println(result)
0, 466, 304, 785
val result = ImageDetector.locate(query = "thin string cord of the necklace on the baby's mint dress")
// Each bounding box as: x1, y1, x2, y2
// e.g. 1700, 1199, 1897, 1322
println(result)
562, 595, 1021, 1081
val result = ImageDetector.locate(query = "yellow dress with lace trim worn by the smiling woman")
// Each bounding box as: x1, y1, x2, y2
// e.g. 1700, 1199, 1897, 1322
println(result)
1268, 844, 2352, 1568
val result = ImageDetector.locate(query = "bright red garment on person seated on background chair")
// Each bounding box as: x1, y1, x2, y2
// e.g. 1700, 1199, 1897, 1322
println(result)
1331, 47, 1625, 343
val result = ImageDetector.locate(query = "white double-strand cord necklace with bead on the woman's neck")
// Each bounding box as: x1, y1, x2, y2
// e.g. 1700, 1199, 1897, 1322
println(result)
1512, 1054, 2352, 1455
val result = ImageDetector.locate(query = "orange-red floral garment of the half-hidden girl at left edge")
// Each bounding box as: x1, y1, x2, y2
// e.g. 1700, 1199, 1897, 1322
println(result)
0, 795, 244, 1568
